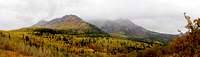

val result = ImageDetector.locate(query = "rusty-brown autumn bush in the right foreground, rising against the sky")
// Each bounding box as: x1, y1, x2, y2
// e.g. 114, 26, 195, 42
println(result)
144, 13, 200, 57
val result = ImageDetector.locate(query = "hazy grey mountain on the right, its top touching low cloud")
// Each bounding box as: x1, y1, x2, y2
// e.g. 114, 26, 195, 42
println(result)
101, 19, 174, 42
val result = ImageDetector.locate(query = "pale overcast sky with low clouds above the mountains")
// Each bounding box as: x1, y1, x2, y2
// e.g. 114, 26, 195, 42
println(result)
0, 0, 200, 33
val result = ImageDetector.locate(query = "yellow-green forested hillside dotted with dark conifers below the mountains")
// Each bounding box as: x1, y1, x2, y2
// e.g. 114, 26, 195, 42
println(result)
0, 28, 159, 57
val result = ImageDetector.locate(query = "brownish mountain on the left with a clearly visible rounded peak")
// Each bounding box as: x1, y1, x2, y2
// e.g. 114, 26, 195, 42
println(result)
32, 15, 103, 33
